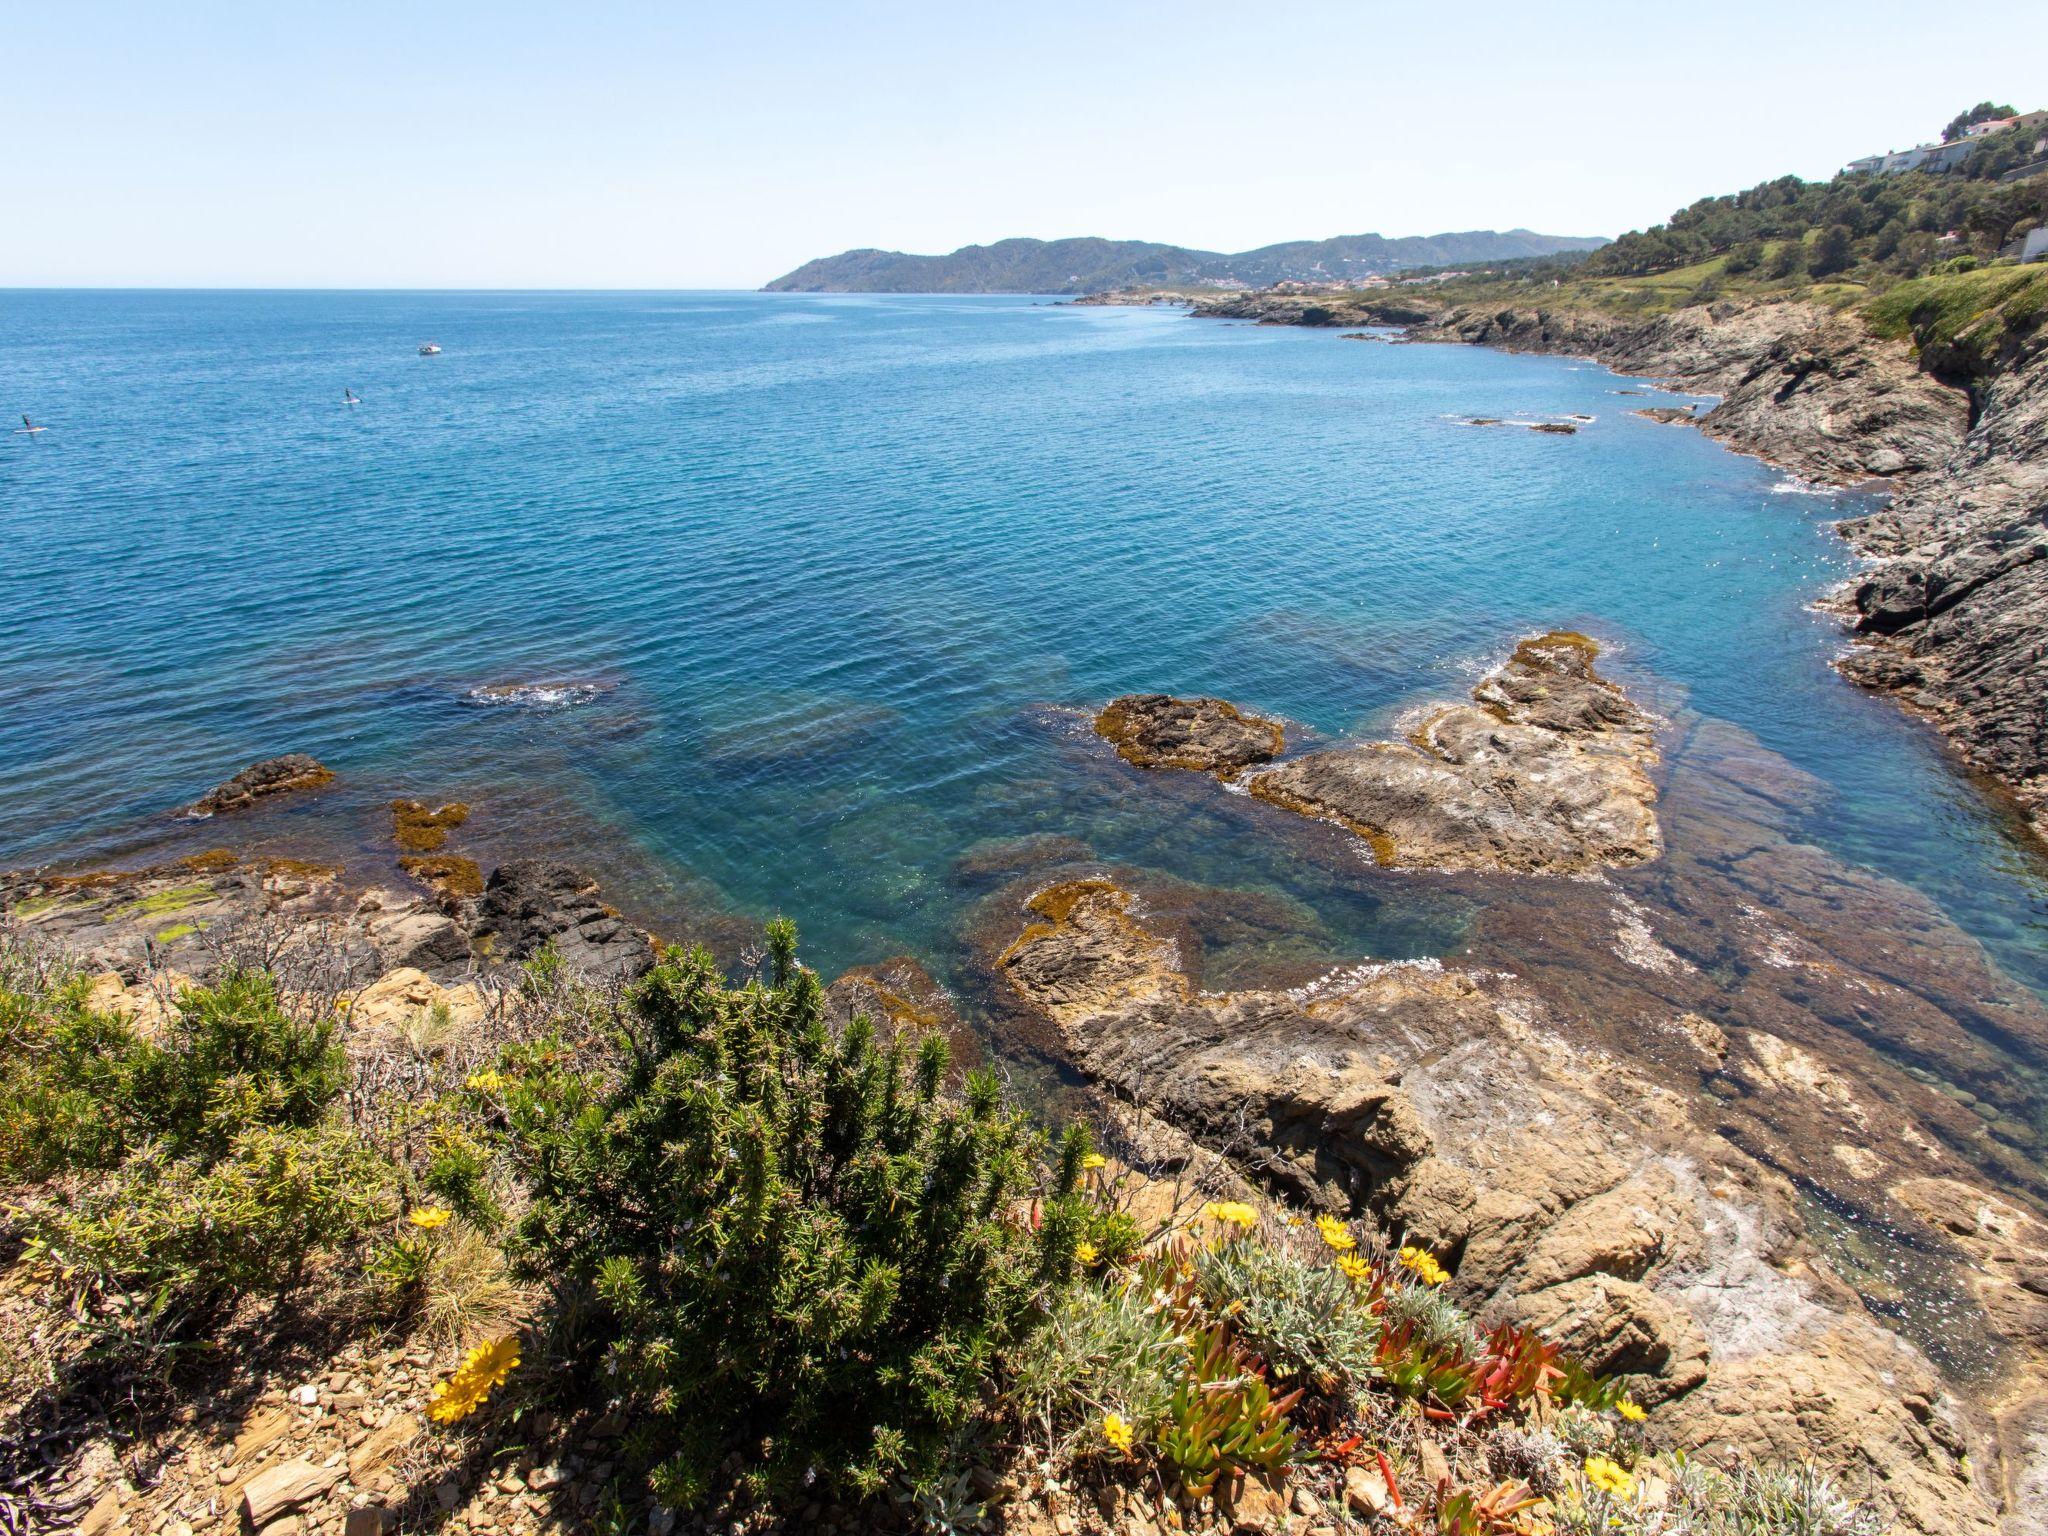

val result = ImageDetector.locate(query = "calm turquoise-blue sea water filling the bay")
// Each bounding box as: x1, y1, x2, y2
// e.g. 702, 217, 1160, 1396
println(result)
12, 293, 2048, 987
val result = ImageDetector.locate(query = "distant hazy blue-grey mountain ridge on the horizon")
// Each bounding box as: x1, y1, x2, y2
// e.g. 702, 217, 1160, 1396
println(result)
766, 229, 1608, 293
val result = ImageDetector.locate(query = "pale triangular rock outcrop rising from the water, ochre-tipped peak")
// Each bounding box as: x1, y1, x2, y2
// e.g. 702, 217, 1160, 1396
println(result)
1249, 633, 1661, 874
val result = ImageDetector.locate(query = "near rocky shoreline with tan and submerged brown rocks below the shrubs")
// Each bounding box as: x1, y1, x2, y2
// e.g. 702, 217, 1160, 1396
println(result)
12, 633, 2048, 1536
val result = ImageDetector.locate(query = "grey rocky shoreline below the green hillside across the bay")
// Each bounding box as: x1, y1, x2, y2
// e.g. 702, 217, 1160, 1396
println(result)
1094, 282, 2048, 838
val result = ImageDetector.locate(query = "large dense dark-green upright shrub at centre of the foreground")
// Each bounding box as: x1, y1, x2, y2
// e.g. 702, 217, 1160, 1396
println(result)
508, 922, 1056, 1505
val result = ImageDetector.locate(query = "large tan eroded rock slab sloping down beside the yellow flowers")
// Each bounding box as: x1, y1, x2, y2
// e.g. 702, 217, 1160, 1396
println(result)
995, 879, 2034, 1536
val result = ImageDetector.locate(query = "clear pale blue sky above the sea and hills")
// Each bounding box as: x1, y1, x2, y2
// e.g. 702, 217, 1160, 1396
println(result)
0, 0, 2048, 287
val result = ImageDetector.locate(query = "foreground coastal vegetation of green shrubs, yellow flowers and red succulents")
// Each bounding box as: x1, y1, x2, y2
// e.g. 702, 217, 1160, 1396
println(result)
0, 922, 1874, 1536
